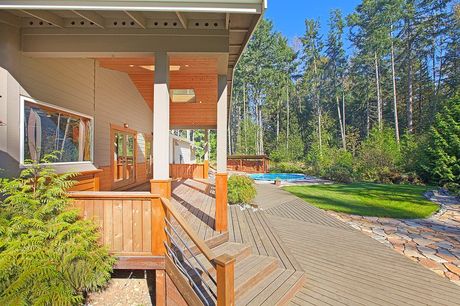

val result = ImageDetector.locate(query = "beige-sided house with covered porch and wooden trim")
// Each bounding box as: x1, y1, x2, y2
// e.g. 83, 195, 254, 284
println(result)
0, 0, 266, 305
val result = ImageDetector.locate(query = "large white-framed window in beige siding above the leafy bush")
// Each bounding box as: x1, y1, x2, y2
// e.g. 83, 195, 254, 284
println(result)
21, 97, 93, 164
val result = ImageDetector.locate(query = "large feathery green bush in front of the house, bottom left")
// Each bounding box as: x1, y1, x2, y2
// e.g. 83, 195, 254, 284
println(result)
0, 154, 115, 305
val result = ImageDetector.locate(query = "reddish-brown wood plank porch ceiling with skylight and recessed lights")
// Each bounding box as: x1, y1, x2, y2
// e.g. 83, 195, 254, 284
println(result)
97, 55, 219, 129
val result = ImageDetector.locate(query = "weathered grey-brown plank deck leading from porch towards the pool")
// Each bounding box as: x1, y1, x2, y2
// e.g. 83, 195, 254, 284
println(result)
129, 179, 460, 305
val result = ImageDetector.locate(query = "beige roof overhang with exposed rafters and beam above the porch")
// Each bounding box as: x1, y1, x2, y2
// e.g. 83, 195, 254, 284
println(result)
0, 0, 267, 123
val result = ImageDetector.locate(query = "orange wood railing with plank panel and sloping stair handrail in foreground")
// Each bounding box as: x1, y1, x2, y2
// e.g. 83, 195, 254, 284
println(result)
69, 191, 235, 306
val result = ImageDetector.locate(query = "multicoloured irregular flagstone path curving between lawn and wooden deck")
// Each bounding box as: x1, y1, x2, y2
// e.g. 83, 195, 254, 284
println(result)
329, 192, 460, 285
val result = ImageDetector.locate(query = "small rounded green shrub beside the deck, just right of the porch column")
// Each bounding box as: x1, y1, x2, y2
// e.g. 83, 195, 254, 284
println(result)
228, 175, 256, 204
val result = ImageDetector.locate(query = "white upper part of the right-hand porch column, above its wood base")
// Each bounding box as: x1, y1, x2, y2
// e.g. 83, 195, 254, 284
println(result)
217, 75, 227, 173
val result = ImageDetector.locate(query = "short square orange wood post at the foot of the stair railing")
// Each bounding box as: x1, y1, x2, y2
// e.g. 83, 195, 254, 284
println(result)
214, 254, 235, 306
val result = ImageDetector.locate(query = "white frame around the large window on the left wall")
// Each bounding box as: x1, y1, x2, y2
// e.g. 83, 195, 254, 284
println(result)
19, 95, 94, 167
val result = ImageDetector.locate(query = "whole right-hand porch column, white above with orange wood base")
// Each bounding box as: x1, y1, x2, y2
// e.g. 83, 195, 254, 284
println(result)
216, 75, 227, 231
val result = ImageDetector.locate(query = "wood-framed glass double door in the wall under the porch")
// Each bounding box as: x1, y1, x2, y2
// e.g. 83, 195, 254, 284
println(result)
113, 130, 136, 188
